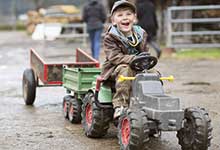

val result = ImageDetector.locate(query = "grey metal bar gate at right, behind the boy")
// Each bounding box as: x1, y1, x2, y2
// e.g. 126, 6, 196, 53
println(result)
166, 5, 220, 48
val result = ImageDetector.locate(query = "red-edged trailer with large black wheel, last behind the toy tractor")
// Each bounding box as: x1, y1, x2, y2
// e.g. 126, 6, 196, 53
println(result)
22, 48, 99, 105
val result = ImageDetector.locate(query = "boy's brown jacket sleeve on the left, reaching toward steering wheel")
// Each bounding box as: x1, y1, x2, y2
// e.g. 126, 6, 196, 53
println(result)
104, 34, 135, 65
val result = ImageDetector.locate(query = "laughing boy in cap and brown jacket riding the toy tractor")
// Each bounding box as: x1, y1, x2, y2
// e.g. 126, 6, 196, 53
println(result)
101, 0, 148, 119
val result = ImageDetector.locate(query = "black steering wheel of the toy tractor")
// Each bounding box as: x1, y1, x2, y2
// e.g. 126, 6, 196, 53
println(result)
130, 55, 157, 71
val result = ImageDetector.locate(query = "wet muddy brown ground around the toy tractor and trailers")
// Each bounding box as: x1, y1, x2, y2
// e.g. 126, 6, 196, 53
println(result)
0, 32, 220, 150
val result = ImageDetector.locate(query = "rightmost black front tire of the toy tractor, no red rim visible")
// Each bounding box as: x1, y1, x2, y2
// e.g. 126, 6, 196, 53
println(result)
177, 107, 212, 150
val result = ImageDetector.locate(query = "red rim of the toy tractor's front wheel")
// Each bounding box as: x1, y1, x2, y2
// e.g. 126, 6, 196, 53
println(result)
121, 118, 131, 146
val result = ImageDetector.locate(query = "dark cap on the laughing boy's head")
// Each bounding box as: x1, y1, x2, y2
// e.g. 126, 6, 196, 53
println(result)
111, 0, 136, 16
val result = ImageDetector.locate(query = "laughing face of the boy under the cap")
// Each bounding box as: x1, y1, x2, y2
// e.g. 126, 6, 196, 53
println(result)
112, 7, 136, 35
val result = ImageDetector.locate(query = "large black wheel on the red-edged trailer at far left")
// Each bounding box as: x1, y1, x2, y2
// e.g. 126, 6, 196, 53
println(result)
22, 69, 36, 105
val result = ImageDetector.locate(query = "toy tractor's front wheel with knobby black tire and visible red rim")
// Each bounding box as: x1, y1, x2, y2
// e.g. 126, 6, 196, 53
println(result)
118, 109, 149, 150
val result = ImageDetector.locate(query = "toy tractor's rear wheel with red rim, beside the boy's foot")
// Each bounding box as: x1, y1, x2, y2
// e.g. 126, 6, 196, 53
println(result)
82, 92, 112, 138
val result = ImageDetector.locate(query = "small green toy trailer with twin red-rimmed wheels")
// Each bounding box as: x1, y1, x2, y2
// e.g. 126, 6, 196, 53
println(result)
60, 61, 101, 123
